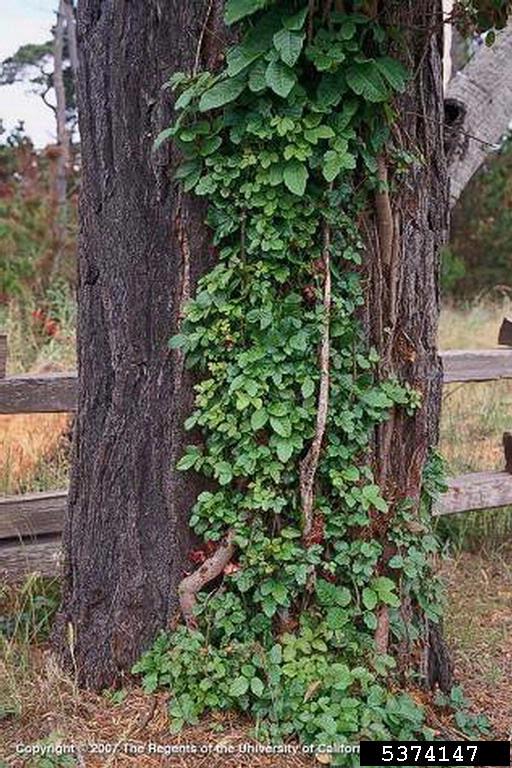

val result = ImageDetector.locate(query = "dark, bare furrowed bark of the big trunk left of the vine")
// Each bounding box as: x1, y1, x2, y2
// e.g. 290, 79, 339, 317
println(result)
54, 0, 223, 689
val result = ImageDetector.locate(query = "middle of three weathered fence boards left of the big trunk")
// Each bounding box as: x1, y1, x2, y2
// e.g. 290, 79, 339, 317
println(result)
0, 490, 67, 539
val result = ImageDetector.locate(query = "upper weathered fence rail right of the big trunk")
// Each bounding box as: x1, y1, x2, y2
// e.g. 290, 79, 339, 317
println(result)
441, 349, 512, 384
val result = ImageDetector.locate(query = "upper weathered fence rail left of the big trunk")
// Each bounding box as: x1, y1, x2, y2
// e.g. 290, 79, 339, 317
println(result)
0, 372, 77, 414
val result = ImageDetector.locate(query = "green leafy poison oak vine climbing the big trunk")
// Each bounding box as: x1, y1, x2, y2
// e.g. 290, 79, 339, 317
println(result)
135, 0, 492, 764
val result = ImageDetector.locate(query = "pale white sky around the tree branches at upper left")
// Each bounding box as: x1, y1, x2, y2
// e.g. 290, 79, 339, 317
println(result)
0, 0, 57, 147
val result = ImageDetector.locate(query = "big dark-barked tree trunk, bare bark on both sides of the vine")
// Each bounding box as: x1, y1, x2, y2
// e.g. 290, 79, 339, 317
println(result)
55, 0, 448, 688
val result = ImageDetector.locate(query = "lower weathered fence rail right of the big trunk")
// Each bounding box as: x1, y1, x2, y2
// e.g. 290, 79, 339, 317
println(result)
433, 472, 512, 516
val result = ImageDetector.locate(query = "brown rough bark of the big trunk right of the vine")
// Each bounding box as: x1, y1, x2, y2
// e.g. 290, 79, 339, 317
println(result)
366, 0, 449, 683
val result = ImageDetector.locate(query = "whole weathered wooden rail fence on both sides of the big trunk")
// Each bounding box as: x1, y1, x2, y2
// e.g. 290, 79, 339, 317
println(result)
0, 319, 512, 579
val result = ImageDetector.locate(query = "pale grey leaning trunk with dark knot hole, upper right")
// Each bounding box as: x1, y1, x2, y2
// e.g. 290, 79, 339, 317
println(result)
446, 23, 512, 205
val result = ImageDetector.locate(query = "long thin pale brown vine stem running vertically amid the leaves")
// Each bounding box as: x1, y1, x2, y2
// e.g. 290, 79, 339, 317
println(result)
299, 221, 332, 539
